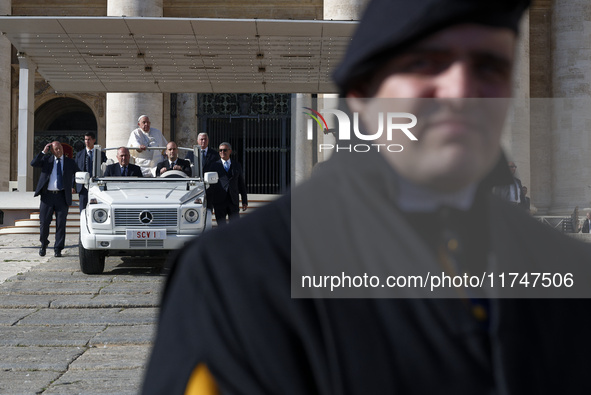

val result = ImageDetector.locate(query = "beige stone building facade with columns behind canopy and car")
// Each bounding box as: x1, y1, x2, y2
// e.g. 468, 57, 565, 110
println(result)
0, 0, 591, 214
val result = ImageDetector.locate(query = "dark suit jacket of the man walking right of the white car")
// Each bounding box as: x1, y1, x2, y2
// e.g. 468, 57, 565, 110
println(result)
210, 159, 248, 206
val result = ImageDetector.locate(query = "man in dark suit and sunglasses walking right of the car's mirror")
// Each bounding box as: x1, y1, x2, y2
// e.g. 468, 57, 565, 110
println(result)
209, 142, 248, 225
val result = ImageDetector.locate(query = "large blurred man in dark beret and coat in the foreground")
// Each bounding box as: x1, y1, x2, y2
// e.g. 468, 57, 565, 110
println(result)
143, 0, 591, 395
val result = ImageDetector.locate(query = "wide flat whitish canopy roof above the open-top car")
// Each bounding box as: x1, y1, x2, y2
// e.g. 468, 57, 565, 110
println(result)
0, 16, 356, 93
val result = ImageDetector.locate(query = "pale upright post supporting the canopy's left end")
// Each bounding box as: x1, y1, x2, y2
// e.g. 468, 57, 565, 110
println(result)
16, 54, 37, 192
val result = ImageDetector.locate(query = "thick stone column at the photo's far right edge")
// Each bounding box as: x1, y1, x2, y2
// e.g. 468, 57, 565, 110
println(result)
547, 0, 591, 215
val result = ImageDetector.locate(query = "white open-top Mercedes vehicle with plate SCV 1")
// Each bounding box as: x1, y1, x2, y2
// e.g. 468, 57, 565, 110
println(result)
76, 145, 218, 274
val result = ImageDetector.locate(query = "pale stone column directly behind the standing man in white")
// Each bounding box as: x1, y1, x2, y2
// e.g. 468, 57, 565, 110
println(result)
105, 0, 164, 158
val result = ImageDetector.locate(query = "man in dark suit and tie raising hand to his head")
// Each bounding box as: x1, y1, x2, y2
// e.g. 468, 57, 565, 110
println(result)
31, 141, 80, 257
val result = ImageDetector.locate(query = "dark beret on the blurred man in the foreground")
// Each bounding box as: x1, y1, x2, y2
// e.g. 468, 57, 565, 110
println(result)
333, 0, 530, 93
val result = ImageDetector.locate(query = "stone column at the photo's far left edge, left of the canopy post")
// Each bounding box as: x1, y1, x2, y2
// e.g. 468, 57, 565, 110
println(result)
0, 0, 12, 191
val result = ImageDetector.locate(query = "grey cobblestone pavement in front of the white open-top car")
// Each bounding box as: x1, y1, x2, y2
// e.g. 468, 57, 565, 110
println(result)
0, 235, 166, 395
